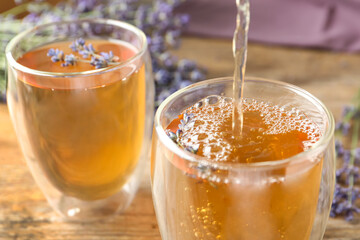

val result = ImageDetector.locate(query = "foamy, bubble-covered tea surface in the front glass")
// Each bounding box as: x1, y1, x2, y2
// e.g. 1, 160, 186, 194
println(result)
169, 96, 320, 163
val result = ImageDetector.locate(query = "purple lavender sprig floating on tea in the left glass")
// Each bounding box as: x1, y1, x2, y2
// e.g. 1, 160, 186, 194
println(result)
47, 38, 119, 69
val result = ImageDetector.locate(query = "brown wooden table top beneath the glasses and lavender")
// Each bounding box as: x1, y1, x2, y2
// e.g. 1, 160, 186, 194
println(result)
0, 38, 360, 240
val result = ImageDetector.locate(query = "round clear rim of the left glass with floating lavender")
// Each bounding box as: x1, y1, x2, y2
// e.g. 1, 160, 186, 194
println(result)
5, 18, 147, 77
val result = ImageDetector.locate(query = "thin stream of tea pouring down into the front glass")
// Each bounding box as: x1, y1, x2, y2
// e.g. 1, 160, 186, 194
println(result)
232, 0, 250, 137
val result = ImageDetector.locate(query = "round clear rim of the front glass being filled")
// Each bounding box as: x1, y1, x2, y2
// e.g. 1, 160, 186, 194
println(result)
154, 76, 335, 170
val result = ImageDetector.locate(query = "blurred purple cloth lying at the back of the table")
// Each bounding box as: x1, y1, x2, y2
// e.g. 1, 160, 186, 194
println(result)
179, 0, 360, 51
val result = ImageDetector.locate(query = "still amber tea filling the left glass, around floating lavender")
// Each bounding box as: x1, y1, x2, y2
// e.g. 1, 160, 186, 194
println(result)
17, 39, 145, 200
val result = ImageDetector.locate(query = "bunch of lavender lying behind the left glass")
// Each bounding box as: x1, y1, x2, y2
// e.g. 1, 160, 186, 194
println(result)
0, 0, 205, 105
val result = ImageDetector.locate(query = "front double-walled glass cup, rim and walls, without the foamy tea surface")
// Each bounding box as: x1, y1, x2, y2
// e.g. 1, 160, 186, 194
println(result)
151, 78, 335, 240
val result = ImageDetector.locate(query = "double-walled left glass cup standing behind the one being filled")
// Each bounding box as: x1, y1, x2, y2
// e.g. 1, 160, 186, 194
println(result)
6, 19, 154, 220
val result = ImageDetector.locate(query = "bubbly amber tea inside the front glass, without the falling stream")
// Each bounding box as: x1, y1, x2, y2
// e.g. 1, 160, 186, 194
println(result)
160, 96, 322, 240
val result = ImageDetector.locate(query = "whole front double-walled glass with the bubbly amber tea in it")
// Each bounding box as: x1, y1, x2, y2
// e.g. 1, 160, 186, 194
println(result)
151, 78, 334, 240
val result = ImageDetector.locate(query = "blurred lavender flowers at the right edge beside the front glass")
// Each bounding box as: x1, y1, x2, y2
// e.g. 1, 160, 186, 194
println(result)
330, 90, 360, 221
